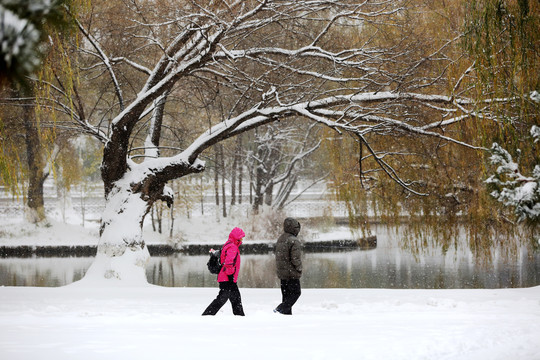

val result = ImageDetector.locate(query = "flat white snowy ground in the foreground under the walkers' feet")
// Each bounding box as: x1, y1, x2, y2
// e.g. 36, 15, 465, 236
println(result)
0, 284, 540, 360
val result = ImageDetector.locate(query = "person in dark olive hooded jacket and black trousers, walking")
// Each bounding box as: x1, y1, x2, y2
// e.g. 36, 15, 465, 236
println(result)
274, 218, 302, 315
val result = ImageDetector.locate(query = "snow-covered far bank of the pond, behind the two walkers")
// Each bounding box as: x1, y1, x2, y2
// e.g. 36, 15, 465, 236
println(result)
0, 217, 368, 257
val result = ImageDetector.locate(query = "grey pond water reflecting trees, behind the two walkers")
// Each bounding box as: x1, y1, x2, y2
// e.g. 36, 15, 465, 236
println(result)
0, 227, 540, 289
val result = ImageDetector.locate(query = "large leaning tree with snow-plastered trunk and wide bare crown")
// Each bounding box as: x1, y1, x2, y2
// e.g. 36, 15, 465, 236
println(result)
41, 0, 506, 281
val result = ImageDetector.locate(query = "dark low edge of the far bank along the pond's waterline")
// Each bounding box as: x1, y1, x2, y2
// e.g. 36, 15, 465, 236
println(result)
0, 236, 377, 258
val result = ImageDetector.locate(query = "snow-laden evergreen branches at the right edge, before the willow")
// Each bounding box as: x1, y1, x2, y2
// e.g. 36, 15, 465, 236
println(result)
486, 126, 540, 224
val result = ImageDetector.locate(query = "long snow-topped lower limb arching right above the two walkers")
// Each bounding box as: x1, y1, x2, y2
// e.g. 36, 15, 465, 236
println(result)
132, 92, 482, 187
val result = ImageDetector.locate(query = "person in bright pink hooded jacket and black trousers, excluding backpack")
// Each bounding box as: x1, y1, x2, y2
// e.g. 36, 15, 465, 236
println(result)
203, 227, 246, 316
